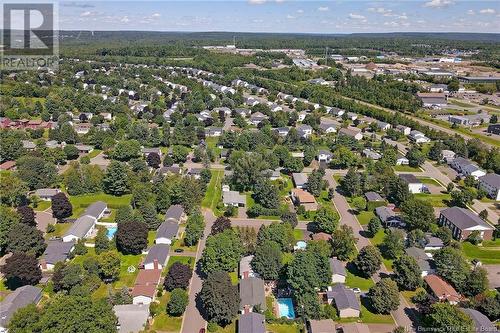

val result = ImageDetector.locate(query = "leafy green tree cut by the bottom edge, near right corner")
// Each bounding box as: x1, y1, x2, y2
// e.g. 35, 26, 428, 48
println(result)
425, 303, 474, 332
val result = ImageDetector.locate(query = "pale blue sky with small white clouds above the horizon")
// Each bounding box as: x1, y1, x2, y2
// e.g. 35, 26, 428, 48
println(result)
11, 0, 500, 33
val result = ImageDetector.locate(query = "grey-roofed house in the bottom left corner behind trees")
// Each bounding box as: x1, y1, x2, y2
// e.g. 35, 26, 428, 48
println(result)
0, 285, 42, 332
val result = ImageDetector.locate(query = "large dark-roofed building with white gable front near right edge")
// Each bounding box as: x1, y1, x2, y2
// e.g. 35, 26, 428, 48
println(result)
438, 207, 494, 240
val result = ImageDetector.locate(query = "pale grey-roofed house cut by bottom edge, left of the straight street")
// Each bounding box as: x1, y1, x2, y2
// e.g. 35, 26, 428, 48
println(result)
113, 304, 149, 333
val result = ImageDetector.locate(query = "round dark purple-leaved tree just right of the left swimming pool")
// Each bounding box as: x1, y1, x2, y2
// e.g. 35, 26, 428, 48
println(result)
116, 221, 148, 254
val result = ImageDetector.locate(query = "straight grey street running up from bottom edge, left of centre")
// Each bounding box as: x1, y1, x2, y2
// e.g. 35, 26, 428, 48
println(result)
181, 209, 215, 333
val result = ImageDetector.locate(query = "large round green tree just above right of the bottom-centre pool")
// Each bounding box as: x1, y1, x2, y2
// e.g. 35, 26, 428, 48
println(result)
287, 249, 332, 294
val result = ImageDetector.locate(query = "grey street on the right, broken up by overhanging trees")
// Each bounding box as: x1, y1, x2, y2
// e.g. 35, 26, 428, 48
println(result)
324, 169, 414, 331
